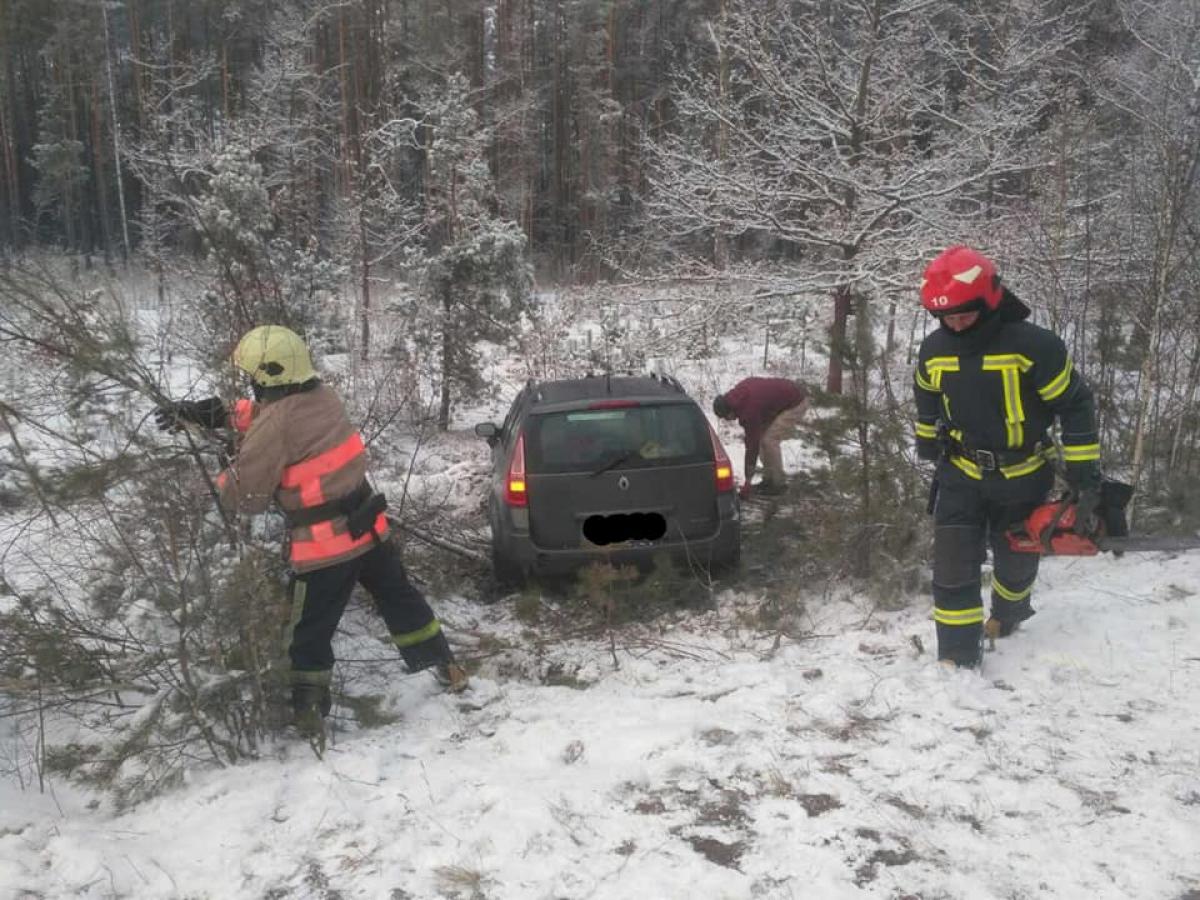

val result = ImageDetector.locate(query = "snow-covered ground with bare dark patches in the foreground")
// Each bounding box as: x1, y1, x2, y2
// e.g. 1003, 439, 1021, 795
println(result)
0, 554, 1200, 900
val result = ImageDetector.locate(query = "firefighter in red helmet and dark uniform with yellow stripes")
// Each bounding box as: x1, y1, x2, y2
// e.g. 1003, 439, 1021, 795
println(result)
913, 246, 1100, 667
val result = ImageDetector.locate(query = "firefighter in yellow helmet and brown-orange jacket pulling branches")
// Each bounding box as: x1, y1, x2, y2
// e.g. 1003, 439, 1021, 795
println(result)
158, 325, 467, 737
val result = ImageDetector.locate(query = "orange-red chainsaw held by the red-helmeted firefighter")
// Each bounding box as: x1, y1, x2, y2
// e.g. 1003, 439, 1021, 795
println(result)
1006, 481, 1200, 557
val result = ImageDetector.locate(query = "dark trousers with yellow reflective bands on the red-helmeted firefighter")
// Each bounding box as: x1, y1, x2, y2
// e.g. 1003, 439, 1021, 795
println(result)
934, 461, 1054, 666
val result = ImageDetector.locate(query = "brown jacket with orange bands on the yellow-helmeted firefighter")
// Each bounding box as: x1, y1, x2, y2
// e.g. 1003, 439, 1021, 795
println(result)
217, 384, 388, 572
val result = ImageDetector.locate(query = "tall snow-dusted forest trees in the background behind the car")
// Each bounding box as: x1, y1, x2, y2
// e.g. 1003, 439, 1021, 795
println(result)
0, 0, 1200, 460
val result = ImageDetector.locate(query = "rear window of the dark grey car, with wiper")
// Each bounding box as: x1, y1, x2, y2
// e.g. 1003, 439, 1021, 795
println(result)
526, 403, 713, 474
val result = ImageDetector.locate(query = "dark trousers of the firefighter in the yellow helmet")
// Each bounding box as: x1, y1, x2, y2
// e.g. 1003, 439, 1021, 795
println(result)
288, 540, 452, 710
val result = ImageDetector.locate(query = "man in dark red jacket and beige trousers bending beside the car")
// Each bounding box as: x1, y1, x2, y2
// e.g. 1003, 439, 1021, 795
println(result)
713, 377, 809, 499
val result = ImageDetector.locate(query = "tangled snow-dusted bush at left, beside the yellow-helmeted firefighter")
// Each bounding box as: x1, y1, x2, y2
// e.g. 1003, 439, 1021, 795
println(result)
0, 264, 297, 800
